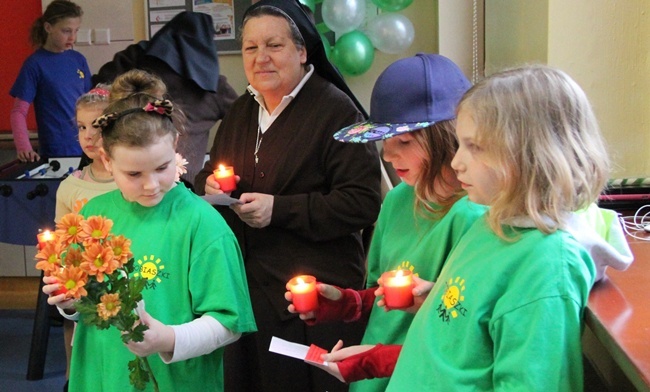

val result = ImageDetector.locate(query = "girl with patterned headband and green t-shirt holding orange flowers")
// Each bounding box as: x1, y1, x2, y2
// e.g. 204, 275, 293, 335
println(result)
43, 89, 256, 391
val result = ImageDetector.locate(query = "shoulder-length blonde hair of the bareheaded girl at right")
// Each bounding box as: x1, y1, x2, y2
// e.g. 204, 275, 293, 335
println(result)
458, 65, 609, 239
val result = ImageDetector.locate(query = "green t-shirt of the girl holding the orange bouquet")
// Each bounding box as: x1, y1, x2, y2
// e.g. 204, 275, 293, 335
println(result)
70, 184, 256, 392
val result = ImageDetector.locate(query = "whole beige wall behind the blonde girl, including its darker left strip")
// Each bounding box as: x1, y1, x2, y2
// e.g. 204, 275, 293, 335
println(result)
485, 0, 650, 177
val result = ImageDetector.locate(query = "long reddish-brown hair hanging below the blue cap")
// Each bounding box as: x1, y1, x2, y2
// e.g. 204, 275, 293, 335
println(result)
412, 120, 463, 219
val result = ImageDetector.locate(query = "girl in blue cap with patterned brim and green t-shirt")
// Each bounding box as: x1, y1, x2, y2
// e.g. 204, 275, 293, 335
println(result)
287, 54, 485, 392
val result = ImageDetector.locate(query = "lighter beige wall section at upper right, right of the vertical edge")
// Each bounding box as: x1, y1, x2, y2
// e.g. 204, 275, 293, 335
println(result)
548, 0, 650, 177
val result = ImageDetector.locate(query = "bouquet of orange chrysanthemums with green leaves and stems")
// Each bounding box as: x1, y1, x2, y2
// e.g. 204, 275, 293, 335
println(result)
36, 213, 158, 390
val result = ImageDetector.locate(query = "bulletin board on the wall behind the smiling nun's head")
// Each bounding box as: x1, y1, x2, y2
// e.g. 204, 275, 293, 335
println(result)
145, 0, 249, 54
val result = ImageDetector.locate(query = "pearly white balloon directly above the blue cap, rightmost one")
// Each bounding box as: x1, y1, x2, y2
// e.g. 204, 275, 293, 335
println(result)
367, 12, 415, 54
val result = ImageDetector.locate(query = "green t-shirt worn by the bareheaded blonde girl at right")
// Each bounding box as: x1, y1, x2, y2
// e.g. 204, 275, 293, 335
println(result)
387, 218, 595, 391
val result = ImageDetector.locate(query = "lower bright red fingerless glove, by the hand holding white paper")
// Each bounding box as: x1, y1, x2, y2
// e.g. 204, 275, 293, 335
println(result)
337, 344, 402, 383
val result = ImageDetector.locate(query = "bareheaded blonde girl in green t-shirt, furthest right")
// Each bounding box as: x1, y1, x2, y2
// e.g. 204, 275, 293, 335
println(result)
387, 66, 609, 391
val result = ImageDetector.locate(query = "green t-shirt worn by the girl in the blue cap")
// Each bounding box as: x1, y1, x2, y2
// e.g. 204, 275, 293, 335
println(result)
350, 183, 486, 392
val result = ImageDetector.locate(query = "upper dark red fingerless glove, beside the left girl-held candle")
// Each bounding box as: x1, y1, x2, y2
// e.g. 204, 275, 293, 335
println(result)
305, 286, 375, 325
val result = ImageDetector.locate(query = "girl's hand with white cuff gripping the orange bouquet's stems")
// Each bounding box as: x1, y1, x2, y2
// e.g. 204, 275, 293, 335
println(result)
126, 309, 176, 357
